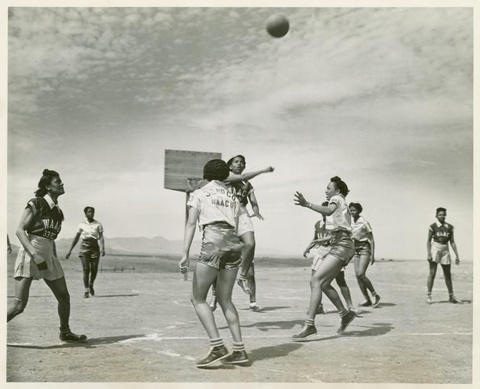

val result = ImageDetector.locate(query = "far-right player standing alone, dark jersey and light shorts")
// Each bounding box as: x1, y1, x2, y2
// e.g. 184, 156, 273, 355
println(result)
427, 208, 462, 304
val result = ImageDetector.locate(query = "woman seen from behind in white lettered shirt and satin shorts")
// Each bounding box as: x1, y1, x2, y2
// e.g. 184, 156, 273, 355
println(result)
179, 159, 248, 368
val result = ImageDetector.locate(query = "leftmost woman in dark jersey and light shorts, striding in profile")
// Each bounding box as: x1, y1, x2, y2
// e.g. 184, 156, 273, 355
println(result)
7, 169, 87, 342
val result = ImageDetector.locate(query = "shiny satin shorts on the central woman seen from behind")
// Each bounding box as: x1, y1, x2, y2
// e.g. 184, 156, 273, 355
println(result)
198, 223, 244, 270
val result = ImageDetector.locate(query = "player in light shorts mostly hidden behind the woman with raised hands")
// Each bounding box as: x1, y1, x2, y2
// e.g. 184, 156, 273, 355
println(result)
303, 201, 355, 315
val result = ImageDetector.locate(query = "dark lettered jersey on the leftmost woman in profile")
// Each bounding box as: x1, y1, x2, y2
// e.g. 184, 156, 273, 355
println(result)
26, 197, 64, 240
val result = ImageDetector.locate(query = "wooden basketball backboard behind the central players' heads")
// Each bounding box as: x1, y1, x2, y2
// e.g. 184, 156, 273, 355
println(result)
163, 149, 222, 192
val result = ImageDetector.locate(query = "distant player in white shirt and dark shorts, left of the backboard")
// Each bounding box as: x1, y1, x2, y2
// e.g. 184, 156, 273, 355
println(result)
66, 207, 105, 298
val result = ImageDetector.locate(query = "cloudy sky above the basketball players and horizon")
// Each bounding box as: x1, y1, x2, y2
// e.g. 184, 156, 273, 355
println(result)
7, 7, 473, 260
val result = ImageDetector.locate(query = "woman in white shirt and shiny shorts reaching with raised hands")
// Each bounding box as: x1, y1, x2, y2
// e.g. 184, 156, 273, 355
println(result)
293, 176, 355, 340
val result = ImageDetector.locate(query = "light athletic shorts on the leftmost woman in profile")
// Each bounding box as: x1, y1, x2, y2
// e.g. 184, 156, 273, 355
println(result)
13, 235, 64, 281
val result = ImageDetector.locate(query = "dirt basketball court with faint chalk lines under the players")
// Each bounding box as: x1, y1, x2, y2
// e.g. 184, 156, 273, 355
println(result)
6, 255, 473, 384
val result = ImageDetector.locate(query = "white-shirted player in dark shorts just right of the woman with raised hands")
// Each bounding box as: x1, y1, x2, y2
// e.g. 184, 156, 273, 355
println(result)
349, 203, 380, 308
